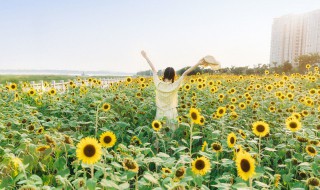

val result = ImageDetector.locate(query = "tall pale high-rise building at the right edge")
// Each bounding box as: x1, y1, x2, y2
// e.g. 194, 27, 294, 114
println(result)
270, 9, 320, 67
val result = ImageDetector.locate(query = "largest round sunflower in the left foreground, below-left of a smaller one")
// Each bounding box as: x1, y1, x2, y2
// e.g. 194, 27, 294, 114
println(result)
76, 137, 102, 164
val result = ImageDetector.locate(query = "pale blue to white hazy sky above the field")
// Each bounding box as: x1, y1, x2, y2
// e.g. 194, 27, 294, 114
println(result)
0, 0, 320, 73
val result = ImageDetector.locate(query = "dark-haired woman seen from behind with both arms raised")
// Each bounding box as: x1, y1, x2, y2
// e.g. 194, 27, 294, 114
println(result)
141, 51, 204, 128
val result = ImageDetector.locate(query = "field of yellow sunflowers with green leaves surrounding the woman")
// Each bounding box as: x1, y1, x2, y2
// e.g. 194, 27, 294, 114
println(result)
0, 67, 320, 190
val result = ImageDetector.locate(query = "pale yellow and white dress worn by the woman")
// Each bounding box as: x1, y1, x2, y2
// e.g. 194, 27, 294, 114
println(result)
153, 72, 183, 120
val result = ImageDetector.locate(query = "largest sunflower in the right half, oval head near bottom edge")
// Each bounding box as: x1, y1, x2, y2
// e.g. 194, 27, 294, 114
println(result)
236, 152, 255, 181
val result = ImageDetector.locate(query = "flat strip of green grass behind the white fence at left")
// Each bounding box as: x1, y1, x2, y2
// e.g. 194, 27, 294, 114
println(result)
0, 75, 124, 84
